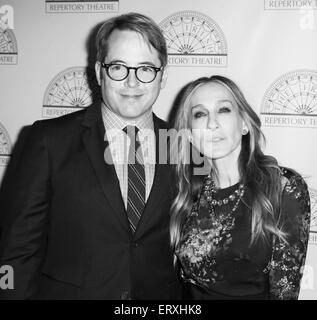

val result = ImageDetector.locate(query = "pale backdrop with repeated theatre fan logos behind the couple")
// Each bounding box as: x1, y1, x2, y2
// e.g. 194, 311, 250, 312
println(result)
0, 0, 317, 299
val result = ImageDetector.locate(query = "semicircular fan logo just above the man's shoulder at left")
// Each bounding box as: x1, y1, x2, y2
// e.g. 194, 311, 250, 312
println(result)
42, 67, 100, 118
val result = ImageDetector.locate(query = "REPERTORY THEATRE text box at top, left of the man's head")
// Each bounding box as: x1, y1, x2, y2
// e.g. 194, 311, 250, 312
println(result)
45, 0, 119, 13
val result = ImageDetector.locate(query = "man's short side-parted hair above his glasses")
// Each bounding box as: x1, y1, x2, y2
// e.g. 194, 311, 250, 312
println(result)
96, 12, 167, 67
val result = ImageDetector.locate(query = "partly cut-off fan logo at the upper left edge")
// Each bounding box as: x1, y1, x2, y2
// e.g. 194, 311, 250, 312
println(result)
0, 26, 18, 64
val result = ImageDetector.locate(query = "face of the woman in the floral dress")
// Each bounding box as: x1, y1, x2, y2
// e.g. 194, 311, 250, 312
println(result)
189, 83, 246, 160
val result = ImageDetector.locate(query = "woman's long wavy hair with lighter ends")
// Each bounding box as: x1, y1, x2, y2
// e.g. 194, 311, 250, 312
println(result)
170, 75, 286, 254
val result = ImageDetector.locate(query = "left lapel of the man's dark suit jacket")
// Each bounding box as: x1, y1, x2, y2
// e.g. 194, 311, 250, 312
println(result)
82, 104, 130, 232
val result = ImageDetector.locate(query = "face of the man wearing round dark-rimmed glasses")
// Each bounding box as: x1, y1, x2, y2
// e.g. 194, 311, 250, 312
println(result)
95, 30, 166, 119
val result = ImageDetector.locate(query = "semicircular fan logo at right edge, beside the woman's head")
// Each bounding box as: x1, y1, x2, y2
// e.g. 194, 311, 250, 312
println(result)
261, 70, 317, 128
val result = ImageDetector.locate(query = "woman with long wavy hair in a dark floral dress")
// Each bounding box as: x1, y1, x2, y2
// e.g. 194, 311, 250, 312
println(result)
170, 76, 310, 299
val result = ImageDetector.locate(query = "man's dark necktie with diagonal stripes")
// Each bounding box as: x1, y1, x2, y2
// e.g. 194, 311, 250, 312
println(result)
123, 126, 145, 233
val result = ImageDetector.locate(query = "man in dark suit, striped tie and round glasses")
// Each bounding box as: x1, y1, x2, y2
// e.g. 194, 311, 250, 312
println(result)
0, 13, 180, 299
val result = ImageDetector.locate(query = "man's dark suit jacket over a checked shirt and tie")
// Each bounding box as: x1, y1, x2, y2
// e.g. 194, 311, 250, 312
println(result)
0, 104, 180, 299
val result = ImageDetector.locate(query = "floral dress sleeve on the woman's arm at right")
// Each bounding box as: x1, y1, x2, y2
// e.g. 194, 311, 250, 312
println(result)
269, 174, 310, 300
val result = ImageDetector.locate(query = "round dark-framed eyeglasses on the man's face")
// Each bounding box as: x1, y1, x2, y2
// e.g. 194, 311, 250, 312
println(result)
101, 62, 163, 83
